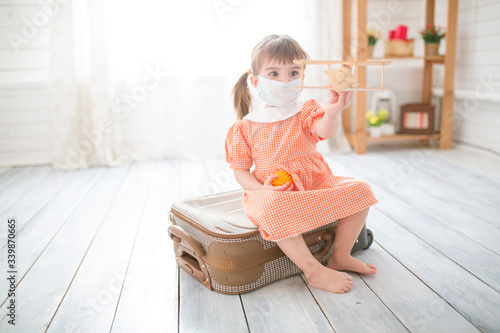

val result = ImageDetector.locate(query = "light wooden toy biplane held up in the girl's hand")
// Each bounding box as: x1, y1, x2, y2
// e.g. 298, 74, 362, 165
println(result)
293, 59, 392, 91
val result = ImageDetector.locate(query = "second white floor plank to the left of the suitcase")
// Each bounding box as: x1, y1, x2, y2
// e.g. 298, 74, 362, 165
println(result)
49, 162, 155, 332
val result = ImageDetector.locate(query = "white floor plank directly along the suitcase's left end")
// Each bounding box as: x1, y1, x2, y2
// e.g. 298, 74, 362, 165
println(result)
111, 161, 180, 333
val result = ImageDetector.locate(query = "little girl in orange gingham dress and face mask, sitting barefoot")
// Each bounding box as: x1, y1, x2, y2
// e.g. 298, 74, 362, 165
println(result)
225, 35, 377, 293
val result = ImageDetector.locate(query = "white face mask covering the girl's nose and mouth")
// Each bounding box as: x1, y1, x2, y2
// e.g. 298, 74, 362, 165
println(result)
257, 75, 302, 107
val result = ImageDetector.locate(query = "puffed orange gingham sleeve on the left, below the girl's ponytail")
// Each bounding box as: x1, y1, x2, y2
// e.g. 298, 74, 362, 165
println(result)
224, 121, 253, 170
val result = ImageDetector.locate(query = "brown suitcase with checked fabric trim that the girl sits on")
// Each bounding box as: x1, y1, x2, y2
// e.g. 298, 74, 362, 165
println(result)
168, 190, 373, 294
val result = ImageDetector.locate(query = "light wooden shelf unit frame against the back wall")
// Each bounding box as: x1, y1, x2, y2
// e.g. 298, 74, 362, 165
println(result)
342, 0, 458, 154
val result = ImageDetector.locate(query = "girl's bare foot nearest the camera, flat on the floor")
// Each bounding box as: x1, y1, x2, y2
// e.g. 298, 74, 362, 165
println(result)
305, 265, 352, 294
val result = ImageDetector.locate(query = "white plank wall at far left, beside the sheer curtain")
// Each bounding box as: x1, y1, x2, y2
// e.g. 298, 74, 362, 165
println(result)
0, 0, 50, 165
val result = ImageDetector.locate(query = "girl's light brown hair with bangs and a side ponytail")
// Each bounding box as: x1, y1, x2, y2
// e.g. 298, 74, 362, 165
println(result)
233, 35, 309, 119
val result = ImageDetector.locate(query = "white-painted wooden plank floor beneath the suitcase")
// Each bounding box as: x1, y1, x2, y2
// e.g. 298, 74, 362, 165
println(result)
0, 145, 500, 333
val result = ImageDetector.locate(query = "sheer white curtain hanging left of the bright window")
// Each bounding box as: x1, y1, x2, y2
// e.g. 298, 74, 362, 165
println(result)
48, 0, 130, 169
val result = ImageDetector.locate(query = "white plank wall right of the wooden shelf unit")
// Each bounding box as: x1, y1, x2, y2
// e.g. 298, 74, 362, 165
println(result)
442, 0, 500, 153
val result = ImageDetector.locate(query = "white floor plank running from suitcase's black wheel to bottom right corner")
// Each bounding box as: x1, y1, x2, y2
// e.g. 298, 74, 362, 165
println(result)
368, 209, 500, 332
